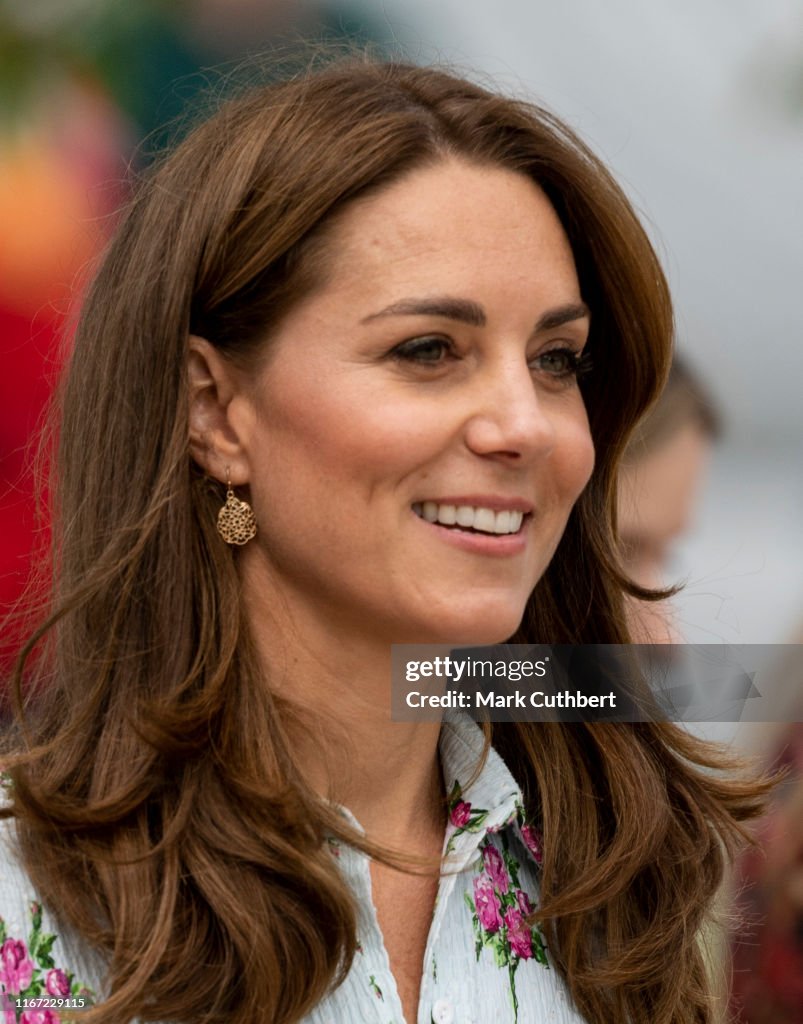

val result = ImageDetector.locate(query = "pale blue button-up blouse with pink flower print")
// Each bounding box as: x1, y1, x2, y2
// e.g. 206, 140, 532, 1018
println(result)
0, 717, 584, 1024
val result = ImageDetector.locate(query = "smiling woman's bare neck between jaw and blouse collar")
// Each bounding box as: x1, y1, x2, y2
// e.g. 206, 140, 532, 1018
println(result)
241, 565, 446, 853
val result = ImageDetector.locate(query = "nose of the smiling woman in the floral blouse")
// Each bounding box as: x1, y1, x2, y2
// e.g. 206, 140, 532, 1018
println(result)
465, 357, 555, 463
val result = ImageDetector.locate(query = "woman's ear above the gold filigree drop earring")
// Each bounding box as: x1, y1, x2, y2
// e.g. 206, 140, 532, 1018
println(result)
187, 335, 250, 486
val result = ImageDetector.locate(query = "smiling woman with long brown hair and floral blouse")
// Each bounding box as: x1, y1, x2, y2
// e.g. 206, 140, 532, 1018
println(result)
0, 62, 757, 1024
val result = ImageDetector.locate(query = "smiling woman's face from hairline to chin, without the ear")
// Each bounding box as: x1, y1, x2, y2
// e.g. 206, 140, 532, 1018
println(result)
233, 161, 594, 643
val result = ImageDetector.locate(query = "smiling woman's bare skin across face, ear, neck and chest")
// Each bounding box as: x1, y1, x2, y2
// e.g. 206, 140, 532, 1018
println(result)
189, 161, 594, 1020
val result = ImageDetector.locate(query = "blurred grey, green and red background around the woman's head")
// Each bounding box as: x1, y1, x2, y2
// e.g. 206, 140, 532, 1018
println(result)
0, 0, 803, 1024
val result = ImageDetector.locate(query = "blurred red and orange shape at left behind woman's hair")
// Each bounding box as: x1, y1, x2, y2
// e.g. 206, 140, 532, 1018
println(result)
0, 81, 127, 688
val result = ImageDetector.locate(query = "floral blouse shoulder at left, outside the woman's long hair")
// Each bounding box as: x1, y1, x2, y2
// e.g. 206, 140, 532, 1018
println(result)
0, 818, 102, 1011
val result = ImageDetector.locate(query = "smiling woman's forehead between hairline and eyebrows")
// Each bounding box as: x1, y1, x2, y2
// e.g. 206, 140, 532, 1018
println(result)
311, 160, 580, 300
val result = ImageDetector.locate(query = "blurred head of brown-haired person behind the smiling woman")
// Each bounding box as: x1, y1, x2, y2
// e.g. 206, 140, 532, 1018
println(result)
617, 354, 720, 643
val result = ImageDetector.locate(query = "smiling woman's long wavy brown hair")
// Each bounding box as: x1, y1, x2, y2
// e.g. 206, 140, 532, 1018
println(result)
5, 59, 760, 1024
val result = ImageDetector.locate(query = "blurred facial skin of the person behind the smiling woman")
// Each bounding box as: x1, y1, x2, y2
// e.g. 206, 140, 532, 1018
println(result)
619, 422, 711, 643
